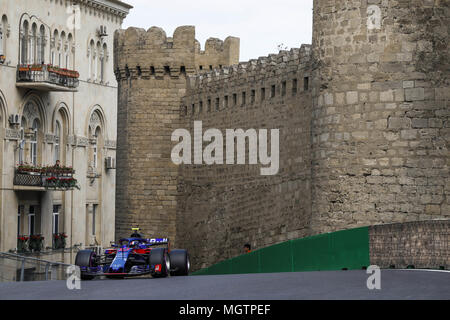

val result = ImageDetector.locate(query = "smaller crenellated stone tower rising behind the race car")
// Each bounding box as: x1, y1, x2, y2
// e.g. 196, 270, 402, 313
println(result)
114, 26, 239, 241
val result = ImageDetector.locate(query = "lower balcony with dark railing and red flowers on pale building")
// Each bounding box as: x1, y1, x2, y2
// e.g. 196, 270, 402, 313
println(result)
13, 166, 80, 192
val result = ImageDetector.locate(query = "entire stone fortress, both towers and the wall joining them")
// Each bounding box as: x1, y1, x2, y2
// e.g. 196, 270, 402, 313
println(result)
115, 0, 450, 269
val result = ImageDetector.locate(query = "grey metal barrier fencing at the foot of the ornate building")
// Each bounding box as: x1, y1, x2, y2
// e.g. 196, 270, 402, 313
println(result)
0, 252, 74, 282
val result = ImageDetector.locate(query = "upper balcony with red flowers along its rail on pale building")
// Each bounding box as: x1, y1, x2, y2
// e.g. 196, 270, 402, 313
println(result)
16, 64, 79, 92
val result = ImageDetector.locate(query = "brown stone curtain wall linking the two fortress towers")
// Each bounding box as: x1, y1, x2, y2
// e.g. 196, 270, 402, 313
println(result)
177, 46, 311, 268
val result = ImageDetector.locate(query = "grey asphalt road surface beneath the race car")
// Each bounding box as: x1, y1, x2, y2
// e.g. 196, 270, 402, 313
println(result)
0, 270, 450, 300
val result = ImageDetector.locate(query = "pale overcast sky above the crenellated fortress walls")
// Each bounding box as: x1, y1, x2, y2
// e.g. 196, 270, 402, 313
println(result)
123, 0, 313, 61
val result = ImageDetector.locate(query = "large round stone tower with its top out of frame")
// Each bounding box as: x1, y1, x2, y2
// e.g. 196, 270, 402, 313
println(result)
312, 0, 450, 233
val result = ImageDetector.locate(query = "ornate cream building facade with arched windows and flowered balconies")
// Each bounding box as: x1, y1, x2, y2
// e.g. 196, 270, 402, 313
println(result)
0, 0, 131, 255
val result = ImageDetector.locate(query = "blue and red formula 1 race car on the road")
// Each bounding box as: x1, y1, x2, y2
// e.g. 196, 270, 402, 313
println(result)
75, 229, 190, 280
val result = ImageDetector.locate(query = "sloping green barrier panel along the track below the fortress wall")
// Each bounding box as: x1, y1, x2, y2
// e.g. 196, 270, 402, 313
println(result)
193, 227, 370, 275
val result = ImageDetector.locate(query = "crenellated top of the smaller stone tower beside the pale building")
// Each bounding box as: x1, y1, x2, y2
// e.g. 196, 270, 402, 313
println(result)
114, 26, 239, 80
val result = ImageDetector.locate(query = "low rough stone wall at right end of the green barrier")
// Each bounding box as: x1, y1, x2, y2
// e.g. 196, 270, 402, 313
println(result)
369, 220, 450, 269
